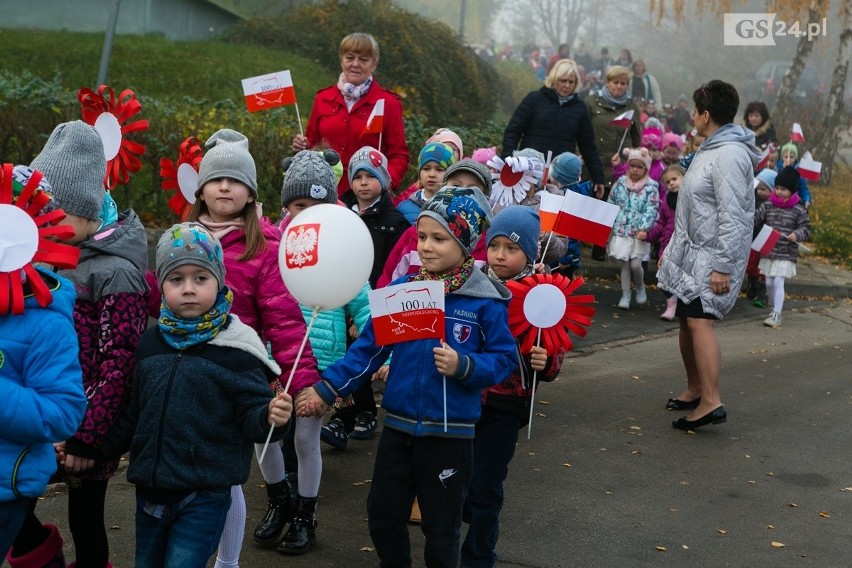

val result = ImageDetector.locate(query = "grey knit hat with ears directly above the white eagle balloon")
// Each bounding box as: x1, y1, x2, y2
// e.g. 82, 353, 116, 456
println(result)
281, 150, 340, 207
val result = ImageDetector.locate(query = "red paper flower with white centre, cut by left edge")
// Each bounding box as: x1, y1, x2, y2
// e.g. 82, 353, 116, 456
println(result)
0, 164, 80, 315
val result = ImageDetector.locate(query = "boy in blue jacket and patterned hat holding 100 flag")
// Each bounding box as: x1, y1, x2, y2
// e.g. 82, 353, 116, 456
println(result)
297, 188, 517, 568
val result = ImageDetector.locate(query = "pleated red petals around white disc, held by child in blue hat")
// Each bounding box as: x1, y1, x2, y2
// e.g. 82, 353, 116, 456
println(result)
506, 274, 595, 354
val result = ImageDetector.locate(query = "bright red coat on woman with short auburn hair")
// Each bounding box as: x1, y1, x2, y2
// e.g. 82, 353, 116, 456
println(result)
305, 79, 408, 196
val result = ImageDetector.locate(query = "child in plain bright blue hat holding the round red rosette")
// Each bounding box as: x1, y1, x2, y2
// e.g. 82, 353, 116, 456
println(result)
461, 205, 564, 566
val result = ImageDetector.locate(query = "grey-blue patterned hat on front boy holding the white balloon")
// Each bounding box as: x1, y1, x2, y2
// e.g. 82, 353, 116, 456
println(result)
157, 223, 225, 290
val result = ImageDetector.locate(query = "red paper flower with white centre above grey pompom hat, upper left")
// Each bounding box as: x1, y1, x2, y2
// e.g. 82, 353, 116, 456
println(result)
77, 85, 148, 191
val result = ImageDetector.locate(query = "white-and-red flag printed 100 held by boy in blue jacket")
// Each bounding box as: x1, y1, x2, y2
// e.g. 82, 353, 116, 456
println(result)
367, 281, 444, 345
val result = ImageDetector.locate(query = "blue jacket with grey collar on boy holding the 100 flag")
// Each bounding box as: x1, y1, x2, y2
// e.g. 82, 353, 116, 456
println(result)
314, 270, 518, 439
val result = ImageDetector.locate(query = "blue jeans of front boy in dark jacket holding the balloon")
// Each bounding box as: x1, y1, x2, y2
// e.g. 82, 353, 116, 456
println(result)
136, 487, 231, 568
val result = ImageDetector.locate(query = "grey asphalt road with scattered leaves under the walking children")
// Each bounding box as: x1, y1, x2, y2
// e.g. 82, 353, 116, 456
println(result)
30, 280, 852, 568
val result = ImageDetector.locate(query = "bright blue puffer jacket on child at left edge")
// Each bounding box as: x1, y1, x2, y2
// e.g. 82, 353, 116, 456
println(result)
0, 269, 87, 503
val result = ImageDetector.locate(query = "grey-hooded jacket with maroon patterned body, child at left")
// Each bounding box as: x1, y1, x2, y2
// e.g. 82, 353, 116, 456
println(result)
57, 210, 148, 480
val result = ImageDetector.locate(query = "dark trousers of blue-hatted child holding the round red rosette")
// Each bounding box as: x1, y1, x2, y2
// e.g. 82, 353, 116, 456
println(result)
461, 406, 523, 568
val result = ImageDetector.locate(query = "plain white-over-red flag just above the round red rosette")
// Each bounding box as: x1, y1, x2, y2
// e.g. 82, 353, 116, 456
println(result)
553, 191, 619, 247
